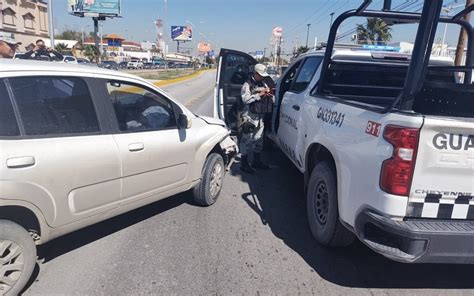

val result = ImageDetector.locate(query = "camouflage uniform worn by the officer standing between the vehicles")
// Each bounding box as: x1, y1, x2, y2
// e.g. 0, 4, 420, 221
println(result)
240, 78, 266, 155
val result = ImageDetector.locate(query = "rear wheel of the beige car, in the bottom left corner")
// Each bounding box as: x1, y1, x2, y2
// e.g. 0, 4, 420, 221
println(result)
0, 220, 36, 295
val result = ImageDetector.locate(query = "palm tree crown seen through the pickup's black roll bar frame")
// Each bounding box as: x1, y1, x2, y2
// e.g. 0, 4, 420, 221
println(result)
357, 17, 392, 44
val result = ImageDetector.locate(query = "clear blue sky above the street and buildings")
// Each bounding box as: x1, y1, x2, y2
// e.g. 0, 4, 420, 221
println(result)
50, 0, 470, 53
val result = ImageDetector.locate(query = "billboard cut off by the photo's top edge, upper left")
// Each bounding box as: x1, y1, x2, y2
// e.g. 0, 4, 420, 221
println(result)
68, 0, 120, 16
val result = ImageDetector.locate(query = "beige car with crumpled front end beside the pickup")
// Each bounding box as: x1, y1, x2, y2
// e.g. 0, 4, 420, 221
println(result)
0, 59, 237, 295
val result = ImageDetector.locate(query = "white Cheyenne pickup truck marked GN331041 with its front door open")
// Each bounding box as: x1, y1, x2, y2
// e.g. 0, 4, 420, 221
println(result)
215, 0, 474, 263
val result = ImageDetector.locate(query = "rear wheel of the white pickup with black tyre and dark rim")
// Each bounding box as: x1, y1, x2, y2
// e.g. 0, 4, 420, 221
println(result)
307, 162, 354, 247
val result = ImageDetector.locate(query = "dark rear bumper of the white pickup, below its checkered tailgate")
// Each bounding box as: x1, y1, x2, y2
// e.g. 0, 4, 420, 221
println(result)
355, 211, 474, 264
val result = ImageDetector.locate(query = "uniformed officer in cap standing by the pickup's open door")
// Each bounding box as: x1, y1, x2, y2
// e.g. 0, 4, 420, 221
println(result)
240, 64, 273, 174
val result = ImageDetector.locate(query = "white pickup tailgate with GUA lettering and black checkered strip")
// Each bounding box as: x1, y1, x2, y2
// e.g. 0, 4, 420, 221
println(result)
407, 117, 474, 220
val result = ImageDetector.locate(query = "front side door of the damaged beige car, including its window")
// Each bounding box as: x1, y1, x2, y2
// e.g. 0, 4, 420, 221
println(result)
104, 80, 195, 203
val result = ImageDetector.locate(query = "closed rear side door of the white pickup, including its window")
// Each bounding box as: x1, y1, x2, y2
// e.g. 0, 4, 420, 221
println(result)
278, 56, 323, 168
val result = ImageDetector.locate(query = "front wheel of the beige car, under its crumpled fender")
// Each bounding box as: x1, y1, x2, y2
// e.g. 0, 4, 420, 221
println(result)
193, 153, 225, 206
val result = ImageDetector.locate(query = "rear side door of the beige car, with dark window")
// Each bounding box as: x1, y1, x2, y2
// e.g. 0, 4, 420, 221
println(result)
0, 76, 121, 227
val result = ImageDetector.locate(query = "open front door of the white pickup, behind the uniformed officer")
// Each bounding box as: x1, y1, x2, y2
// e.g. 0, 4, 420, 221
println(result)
214, 49, 257, 132
